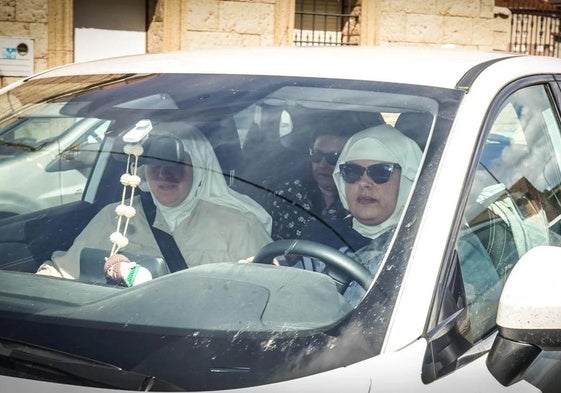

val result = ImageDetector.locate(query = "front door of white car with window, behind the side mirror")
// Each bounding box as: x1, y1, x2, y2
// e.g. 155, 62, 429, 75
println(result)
422, 77, 561, 392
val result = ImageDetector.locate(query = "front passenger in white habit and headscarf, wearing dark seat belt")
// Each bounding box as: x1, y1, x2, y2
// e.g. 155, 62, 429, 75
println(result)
38, 130, 271, 279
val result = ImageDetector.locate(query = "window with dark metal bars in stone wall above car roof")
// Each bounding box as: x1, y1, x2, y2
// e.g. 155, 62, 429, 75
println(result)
293, 0, 360, 46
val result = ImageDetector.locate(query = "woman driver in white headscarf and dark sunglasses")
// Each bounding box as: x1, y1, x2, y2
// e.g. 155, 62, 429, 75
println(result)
309, 124, 422, 306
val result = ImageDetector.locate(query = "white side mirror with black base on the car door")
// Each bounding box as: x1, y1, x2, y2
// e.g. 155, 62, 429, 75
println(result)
487, 246, 561, 386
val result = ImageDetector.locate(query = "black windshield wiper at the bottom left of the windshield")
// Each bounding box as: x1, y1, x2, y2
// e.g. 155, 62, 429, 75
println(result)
0, 338, 183, 392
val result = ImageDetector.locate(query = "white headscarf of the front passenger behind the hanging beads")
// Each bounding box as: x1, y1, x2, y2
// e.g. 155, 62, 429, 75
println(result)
142, 128, 272, 234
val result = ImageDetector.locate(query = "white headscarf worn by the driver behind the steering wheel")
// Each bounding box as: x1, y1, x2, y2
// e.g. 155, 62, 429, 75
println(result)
333, 124, 422, 239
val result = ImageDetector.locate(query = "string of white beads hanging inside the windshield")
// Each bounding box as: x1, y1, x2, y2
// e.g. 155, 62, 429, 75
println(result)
109, 143, 144, 256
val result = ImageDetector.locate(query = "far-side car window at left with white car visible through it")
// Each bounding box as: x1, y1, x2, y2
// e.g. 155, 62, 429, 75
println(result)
0, 112, 110, 219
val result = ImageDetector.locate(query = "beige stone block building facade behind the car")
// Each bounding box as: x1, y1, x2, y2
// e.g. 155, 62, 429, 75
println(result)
0, 0, 510, 86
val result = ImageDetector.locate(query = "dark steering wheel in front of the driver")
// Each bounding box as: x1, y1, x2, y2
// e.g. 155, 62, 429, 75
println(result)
253, 240, 372, 293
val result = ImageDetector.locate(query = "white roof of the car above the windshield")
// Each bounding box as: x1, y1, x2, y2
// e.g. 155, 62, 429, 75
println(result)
28, 46, 514, 88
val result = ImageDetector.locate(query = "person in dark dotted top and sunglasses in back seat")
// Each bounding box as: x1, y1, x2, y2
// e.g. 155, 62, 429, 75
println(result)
265, 128, 350, 240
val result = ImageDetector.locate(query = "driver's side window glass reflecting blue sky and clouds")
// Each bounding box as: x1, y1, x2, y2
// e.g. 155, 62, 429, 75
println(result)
456, 85, 561, 342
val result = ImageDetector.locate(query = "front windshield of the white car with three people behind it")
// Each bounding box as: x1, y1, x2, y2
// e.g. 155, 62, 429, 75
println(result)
0, 74, 461, 390
